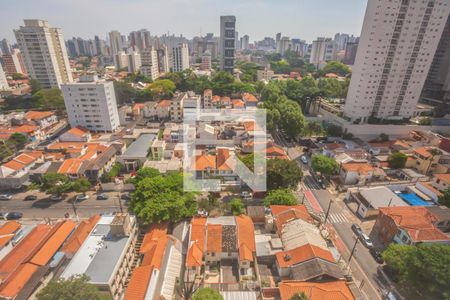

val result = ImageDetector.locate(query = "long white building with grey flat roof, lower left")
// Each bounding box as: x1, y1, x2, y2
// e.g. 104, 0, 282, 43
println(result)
61, 214, 137, 299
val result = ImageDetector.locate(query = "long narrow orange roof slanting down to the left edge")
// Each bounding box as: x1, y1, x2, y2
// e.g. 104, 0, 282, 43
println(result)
0, 224, 52, 280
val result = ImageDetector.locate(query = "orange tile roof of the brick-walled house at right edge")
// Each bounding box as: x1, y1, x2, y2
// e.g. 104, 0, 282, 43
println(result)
379, 206, 450, 242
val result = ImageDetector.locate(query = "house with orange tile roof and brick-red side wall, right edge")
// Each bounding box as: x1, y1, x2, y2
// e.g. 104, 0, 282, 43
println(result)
372, 206, 450, 245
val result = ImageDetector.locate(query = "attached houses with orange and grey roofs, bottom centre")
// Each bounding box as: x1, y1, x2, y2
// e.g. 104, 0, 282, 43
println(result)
186, 215, 257, 290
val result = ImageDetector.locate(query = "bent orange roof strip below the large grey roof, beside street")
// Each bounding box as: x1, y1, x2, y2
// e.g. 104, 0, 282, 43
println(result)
275, 244, 335, 268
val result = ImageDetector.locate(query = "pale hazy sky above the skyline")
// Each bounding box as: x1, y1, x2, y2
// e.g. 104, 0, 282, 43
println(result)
0, 0, 367, 42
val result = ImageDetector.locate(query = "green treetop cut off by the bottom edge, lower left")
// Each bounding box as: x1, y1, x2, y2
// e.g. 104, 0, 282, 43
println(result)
36, 275, 108, 300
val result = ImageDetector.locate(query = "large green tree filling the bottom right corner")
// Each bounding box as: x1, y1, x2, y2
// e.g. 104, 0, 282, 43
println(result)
382, 243, 450, 299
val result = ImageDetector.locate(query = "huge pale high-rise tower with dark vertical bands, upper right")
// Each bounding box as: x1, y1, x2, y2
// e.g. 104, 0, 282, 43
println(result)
344, 0, 450, 123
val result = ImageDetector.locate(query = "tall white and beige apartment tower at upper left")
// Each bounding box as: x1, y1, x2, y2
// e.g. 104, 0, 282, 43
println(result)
14, 20, 73, 88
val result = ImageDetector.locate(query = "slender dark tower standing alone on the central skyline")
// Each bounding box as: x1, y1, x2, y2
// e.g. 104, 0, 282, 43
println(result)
219, 16, 236, 74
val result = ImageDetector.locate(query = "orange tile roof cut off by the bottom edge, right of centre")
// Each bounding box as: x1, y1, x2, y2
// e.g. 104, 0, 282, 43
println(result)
279, 280, 355, 300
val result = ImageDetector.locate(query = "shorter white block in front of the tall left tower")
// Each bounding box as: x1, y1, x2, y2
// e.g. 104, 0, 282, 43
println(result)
61, 75, 119, 132
